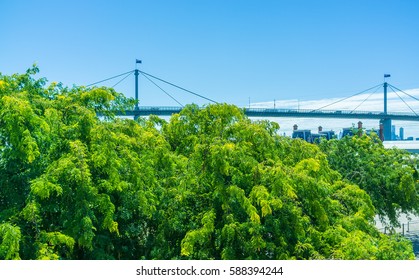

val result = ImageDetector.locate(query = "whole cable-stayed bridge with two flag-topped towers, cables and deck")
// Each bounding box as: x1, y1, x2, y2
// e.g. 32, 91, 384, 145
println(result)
87, 60, 419, 140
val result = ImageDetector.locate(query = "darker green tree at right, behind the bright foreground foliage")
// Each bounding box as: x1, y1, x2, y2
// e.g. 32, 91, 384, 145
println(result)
320, 134, 419, 225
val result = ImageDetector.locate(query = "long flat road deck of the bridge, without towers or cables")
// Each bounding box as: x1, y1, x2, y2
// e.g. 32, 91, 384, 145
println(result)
118, 106, 419, 121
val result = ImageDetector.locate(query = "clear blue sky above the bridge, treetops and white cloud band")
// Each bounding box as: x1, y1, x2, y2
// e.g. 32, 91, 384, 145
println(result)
0, 0, 419, 133
